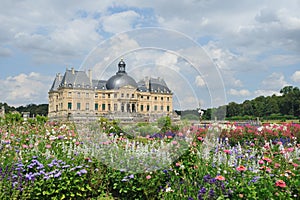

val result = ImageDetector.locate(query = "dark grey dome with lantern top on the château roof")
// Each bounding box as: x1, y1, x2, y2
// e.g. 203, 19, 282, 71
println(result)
106, 60, 138, 90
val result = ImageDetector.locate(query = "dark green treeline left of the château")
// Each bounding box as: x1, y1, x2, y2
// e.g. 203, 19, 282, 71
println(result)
0, 102, 48, 117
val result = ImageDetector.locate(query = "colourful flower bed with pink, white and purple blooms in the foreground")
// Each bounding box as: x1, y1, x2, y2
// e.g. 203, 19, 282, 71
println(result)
0, 119, 300, 199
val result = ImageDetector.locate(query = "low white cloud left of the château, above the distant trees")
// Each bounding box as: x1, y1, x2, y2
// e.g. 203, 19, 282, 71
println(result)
0, 72, 53, 106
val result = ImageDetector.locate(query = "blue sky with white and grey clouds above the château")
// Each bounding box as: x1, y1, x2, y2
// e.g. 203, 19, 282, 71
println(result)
0, 0, 300, 109
